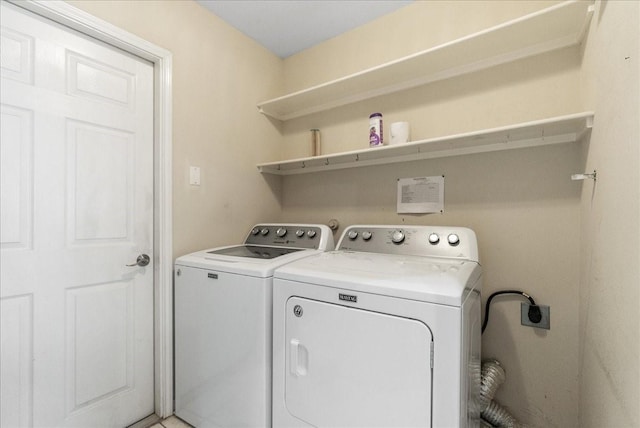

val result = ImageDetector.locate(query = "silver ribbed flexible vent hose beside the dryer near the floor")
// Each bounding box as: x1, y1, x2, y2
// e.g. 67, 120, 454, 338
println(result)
479, 360, 524, 428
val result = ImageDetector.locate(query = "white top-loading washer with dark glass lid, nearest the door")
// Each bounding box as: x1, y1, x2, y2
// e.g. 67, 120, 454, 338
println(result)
174, 224, 334, 428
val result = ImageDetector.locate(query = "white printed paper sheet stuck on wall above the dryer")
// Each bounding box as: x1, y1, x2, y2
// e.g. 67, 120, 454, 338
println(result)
397, 175, 444, 214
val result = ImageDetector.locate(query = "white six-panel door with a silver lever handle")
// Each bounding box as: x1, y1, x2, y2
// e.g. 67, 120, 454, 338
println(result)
0, 1, 154, 427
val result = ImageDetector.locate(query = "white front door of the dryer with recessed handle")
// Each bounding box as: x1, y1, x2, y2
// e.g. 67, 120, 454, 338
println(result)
285, 297, 433, 427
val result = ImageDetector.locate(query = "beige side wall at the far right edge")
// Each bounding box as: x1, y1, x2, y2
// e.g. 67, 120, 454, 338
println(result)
579, 1, 640, 427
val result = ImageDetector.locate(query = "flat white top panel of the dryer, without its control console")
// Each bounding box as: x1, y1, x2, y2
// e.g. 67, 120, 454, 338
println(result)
274, 251, 482, 306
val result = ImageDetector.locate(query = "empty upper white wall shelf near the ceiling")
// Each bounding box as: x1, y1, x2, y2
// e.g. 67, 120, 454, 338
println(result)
258, 0, 593, 120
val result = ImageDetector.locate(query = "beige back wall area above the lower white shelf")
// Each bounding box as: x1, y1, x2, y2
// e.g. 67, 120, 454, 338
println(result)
283, 1, 580, 158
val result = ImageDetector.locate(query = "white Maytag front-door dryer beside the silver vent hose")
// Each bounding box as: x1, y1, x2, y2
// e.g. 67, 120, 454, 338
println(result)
273, 226, 482, 428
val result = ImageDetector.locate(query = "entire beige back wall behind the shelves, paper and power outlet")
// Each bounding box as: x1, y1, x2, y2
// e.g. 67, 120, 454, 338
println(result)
282, 2, 585, 427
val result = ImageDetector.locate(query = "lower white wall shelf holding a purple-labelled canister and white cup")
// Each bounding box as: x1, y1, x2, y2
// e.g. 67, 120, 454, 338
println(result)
258, 112, 594, 175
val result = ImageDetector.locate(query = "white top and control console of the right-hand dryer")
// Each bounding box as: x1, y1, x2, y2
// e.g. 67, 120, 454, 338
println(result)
274, 226, 482, 306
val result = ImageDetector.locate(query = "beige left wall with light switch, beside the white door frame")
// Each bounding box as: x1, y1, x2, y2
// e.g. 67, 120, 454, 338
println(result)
69, 0, 283, 257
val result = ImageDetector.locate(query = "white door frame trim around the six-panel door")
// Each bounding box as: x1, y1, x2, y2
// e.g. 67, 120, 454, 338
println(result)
7, 0, 173, 418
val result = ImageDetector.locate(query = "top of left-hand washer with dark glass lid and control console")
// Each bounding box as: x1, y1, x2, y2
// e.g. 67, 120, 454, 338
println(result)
176, 223, 334, 278
